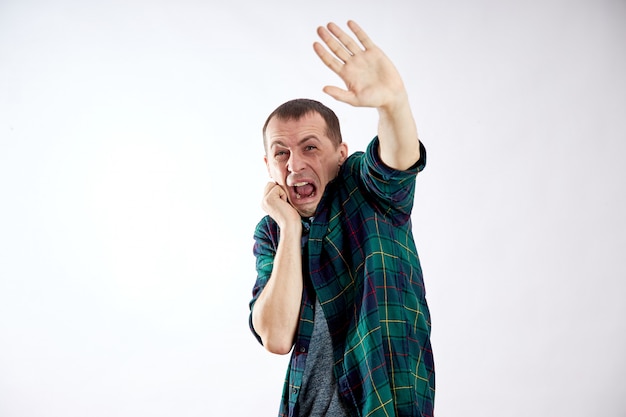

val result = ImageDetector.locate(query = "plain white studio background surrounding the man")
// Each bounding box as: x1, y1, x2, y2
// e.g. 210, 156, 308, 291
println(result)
0, 0, 626, 417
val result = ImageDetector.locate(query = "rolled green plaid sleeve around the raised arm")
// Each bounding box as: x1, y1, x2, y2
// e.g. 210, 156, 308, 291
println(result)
361, 137, 426, 224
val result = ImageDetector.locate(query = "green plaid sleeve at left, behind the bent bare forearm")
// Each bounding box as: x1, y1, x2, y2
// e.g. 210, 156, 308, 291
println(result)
248, 216, 278, 344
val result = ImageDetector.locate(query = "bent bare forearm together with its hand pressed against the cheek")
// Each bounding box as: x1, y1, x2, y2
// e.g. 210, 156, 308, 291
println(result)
252, 183, 303, 355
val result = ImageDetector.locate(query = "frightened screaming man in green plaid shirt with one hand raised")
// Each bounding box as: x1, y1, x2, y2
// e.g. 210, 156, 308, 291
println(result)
250, 21, 435, 417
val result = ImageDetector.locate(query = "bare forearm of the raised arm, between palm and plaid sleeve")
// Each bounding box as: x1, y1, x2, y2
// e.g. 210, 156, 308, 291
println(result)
378, 93, 420, 171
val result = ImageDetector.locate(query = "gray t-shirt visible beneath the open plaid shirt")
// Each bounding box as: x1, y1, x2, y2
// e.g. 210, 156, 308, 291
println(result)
299, 300, 348, 417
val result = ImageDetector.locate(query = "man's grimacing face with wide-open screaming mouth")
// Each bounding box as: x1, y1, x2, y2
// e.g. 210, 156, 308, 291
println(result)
265, 112, 348, 217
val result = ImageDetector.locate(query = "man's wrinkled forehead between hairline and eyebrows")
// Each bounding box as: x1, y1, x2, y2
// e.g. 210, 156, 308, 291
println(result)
265, 112, 327, 147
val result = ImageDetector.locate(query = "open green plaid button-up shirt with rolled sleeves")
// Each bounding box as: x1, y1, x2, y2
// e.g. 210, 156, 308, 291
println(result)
250, 138, 435, 417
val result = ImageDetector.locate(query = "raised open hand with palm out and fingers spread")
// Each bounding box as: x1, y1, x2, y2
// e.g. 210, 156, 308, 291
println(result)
313, 21, 407, 109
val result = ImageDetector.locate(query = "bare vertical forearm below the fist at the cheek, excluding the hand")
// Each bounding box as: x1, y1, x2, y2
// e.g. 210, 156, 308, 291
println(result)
252, 223, 303, 354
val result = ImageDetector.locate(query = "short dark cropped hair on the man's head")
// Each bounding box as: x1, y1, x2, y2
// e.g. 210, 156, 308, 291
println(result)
263, 98, 342, 149
